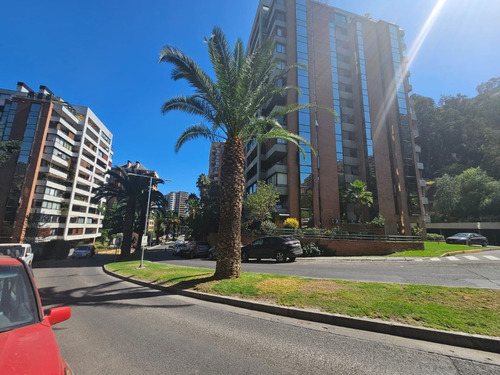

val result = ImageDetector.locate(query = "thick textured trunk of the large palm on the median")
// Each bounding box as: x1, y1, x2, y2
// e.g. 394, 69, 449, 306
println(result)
214, 138, 245, 279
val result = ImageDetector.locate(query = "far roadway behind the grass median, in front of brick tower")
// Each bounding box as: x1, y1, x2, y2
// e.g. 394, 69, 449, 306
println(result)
153, 246, 500, 289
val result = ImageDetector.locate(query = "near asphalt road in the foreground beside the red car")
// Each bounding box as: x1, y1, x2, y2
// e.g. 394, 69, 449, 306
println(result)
34, 255, 500, 375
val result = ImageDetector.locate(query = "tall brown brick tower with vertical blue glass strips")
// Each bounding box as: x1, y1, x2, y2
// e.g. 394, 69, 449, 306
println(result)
245, 0, 425, 234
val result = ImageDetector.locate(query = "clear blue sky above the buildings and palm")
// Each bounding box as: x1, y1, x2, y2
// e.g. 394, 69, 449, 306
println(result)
0, 0, 500, 197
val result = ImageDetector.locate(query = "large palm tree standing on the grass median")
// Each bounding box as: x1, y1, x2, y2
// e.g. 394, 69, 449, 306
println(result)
159, 27, 326, 279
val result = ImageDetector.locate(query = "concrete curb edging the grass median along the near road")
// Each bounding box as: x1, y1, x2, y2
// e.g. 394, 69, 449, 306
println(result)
103, 265, 500, 354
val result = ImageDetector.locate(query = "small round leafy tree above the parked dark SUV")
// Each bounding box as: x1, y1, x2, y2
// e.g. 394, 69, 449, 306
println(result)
245, 181, 279, 223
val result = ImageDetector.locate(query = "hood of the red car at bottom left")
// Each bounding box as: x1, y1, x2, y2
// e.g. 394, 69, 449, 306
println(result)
0, 321, 64, 375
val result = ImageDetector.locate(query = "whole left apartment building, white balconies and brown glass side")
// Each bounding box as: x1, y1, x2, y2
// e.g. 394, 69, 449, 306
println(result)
0, 82, 113, 242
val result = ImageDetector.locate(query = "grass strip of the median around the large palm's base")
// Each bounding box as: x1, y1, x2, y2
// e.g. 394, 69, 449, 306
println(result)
106, 261, 500, 336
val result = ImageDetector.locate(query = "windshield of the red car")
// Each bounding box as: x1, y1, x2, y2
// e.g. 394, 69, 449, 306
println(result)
0, 265, 39, 332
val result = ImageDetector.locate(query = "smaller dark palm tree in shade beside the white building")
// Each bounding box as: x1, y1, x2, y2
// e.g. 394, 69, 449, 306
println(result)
92, 167, 163, 257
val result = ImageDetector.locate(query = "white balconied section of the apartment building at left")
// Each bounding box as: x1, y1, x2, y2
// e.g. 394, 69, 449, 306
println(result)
31, 88, 113, 242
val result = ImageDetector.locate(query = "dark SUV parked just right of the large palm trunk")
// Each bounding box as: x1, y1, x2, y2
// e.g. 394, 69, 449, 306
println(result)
241, 236, 303, 262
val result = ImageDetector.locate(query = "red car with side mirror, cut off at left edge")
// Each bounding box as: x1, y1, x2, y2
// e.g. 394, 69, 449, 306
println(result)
0, 256, 72, 375
